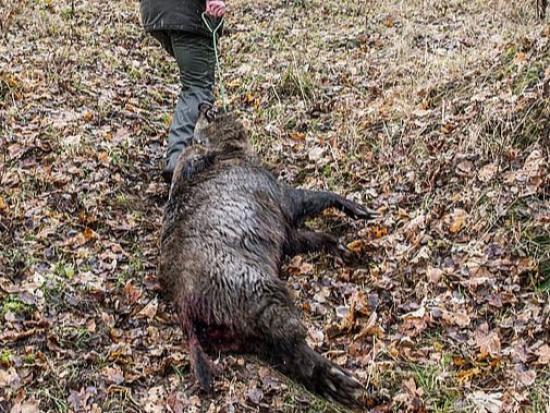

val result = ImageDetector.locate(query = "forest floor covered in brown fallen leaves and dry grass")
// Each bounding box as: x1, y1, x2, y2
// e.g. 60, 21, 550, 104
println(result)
0, 0, 550, 413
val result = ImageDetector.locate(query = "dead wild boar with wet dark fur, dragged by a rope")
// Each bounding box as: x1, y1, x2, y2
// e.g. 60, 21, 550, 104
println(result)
159, 105, 380, 407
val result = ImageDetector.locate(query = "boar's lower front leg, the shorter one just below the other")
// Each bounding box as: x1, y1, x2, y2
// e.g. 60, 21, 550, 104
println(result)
285, 230, 354, 264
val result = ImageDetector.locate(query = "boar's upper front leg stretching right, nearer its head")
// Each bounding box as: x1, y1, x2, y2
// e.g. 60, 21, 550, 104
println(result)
285, 188, 377, 225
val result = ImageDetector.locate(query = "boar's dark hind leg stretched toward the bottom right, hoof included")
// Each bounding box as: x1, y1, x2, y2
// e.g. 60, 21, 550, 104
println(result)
270, 341, 367, 408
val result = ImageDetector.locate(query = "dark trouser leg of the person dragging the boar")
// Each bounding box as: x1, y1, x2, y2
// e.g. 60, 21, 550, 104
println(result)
163, 32, 216, 182
